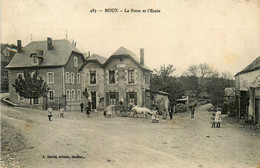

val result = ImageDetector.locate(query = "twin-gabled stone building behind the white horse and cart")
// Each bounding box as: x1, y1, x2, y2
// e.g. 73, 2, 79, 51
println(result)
79, 47, 151, 109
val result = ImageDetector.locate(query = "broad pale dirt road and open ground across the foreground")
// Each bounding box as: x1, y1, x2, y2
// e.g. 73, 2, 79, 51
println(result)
1, 100, 260, 168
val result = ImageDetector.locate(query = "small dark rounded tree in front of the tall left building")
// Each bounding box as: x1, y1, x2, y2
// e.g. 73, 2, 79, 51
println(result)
13, 70, 49, 104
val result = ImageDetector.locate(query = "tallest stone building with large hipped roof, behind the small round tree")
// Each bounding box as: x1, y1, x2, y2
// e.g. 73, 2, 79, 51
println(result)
6, 38, 84, 110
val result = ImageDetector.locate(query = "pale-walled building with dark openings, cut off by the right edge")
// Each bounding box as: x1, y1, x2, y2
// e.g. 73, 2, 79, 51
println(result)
235, 57, 260, 123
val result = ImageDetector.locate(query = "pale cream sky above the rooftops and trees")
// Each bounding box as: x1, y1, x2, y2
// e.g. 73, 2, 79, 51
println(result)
1, 0, 260, 75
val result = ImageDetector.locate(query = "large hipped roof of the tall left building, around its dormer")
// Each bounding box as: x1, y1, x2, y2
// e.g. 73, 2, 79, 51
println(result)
6, 40, 83, 68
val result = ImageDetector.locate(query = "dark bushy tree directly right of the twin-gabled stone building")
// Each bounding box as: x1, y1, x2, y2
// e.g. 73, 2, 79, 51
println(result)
151, 65, 184, 106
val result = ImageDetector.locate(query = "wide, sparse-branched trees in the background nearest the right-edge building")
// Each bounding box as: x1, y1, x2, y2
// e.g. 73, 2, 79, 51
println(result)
181, 63, 234, 106
